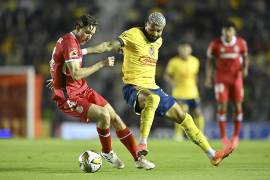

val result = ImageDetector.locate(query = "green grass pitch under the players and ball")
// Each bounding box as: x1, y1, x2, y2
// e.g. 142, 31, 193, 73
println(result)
0, 139, 270, 180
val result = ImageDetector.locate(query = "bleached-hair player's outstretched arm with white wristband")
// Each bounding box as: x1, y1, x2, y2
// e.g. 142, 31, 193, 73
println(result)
82, 40, 121, 55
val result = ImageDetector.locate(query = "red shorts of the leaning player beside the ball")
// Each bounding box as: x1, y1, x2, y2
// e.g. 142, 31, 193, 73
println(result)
55, 88, 108, 122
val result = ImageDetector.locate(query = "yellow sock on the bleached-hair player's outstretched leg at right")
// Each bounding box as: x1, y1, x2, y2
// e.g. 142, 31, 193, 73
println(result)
181, 113, 212, 153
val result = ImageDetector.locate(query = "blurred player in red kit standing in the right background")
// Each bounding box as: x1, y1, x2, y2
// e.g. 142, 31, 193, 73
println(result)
205, 22, 249, 149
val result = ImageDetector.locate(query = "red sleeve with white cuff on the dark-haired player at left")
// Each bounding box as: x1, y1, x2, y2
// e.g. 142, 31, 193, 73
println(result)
62, 39, 82, 62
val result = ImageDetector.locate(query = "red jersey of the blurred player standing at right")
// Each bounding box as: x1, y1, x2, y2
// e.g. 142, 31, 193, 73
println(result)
207, 37, 248, 82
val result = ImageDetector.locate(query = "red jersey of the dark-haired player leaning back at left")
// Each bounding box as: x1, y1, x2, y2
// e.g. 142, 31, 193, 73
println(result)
50, 32, 88, 99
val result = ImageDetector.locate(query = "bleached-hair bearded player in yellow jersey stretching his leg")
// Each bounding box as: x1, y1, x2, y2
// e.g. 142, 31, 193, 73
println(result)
82, 12, 231, 166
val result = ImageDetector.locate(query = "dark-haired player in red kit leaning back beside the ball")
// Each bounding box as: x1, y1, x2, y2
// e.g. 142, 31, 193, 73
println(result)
50, 15, 155, 169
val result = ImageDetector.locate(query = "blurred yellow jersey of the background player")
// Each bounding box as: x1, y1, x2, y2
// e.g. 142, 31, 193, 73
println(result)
166, 55, 200, 99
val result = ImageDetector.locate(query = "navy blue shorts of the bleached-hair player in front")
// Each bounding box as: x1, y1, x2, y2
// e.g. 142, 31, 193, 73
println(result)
122, 84, 176, 116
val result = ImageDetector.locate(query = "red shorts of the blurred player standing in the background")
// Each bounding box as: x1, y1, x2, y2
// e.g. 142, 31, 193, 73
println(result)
215, 78, 244, 103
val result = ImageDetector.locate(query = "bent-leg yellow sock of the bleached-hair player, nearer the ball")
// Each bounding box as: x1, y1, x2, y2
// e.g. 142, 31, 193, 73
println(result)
140, 94, 160, 139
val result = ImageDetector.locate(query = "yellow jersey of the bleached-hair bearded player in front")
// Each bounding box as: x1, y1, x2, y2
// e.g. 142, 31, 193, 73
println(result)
119, 27, 162, 89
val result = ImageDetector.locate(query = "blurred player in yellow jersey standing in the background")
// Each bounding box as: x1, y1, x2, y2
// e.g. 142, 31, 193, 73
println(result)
165, 43, 204, 140
